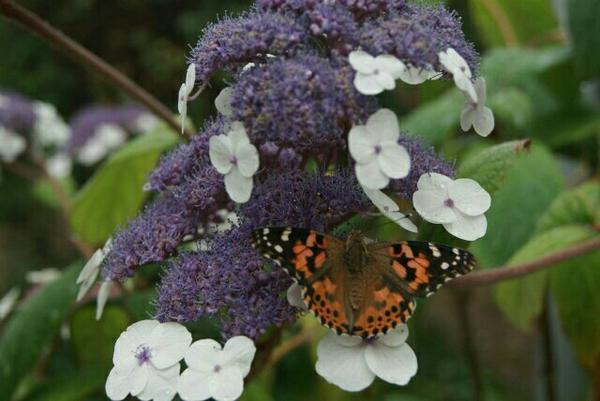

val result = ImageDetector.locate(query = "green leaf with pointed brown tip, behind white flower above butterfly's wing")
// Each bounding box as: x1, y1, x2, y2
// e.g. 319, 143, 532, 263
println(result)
457, 139, 531, 194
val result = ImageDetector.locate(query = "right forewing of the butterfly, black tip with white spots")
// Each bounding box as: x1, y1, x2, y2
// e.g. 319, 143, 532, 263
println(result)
369, 241, 475, 297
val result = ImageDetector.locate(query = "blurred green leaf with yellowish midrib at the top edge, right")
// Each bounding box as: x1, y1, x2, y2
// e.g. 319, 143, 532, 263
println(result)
469, 0, 558, 46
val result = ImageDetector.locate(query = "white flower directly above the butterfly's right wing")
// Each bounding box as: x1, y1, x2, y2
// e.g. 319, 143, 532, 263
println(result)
413, 173, 491, 241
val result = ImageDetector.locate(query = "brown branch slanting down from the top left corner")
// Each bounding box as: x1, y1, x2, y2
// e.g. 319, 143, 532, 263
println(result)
0, 0, 192, 139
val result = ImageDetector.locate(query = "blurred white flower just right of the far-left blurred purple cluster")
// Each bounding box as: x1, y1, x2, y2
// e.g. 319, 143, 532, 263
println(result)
33, 102, 71, 147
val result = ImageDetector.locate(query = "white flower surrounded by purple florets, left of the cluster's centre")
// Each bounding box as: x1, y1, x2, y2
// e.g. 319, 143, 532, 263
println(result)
209, 121, 259, 203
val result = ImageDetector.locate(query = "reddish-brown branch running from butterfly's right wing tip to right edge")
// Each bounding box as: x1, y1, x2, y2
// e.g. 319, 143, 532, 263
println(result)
453, 237, 600, 287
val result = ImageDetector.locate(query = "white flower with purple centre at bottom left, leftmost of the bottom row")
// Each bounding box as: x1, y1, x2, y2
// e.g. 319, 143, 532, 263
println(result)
105, 320, 192, 401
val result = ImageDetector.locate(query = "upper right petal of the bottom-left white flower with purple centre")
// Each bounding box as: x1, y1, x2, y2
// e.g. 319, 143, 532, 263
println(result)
149, 323, 192, 369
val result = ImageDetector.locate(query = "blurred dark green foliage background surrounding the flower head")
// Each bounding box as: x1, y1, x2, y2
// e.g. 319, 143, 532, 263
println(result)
0, 0, 600, 401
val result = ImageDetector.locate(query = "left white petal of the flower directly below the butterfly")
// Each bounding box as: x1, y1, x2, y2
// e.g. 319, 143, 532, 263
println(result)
315, 333, 375, 391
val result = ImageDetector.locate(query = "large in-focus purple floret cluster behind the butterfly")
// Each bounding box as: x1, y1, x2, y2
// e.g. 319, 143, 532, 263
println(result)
103, 0, 478, 338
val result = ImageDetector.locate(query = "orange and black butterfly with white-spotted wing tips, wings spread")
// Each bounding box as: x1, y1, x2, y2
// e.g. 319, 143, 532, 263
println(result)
251, 227, 475, 339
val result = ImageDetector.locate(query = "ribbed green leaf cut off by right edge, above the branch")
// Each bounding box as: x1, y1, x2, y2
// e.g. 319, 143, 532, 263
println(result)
537, 180, 600, 232
